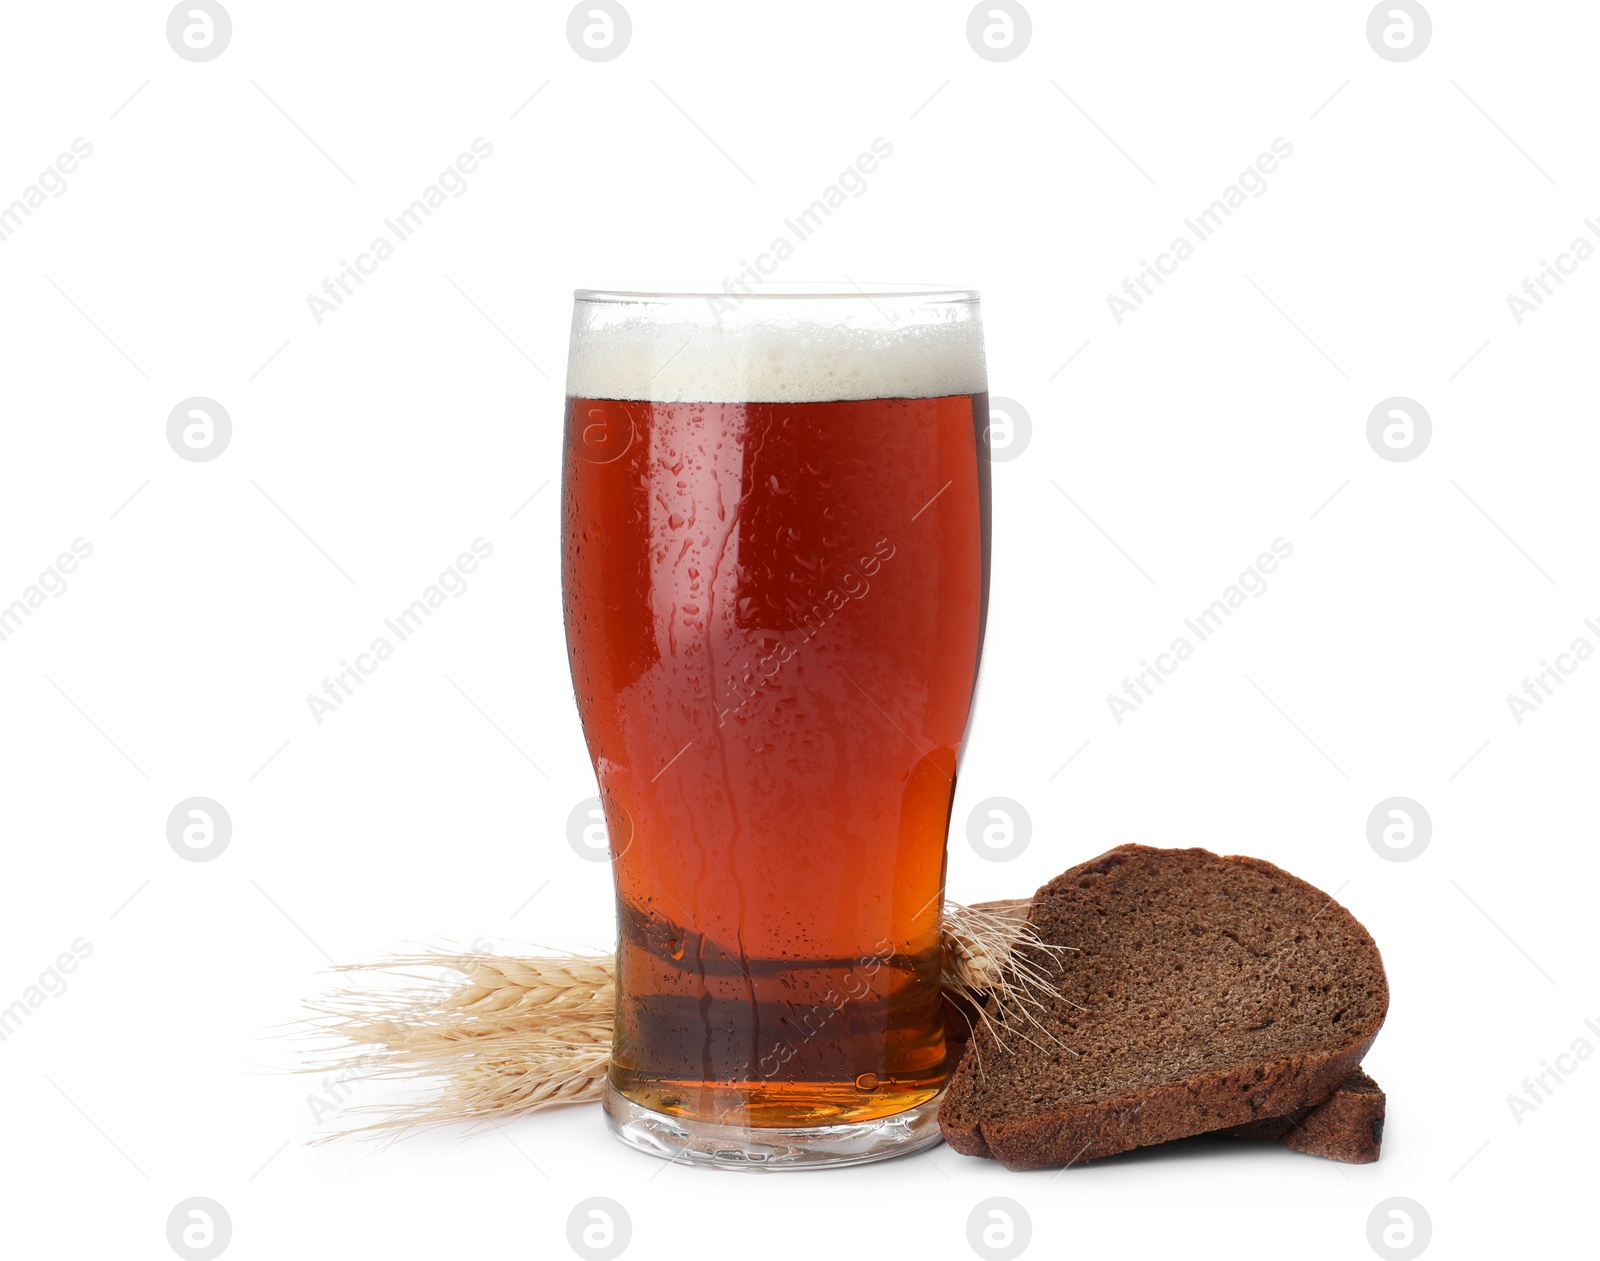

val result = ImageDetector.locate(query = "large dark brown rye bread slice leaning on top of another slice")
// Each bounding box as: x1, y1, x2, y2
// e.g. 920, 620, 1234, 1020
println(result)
939, 845, 1389, 1170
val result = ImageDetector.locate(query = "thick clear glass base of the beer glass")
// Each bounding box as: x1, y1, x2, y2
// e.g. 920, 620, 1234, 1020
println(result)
605, 1082, 944, 1170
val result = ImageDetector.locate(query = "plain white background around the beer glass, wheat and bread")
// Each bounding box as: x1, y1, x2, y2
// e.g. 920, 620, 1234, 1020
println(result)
0, 0, 1600, 1258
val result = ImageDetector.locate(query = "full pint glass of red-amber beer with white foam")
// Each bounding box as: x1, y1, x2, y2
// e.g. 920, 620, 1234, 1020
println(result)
562, 288, 989, 1168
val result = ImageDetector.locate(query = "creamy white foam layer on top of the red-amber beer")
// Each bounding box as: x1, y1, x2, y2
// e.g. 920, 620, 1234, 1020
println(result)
566, 314, 987, 403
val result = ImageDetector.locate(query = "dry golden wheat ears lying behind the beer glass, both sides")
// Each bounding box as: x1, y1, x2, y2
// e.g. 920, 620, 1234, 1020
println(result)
307, 898, 1064, 1141
